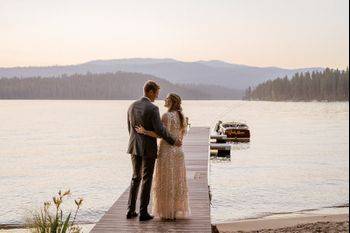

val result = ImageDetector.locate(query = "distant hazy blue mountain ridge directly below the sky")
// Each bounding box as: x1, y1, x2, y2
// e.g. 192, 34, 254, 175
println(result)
0, 58, 323, 90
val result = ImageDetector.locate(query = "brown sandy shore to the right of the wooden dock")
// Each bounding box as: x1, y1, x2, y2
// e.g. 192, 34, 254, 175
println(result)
216, 208, 349, 233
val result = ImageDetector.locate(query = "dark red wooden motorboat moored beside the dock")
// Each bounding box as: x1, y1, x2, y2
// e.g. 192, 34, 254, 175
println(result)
214, 121, 250, 142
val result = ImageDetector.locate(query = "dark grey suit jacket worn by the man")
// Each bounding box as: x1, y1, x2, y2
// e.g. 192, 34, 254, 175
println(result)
127, 97, 175, 158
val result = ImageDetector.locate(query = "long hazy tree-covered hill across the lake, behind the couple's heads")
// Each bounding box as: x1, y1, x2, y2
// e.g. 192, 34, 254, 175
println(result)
0, 72, 244, 100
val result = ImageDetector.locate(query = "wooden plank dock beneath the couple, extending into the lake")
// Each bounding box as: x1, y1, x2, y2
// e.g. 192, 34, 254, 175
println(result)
91, 127, 211, 233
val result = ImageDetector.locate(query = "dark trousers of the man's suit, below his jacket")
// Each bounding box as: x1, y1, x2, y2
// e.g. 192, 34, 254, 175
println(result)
128, 155, 156, 215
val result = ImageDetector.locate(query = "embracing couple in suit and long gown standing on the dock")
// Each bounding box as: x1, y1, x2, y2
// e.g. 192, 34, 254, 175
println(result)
126, 81, 190, 221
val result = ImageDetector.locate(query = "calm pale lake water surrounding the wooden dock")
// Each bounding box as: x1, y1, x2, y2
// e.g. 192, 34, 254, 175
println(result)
0, 100, 349, 224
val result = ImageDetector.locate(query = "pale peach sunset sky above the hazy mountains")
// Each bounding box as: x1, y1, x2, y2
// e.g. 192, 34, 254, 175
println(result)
0, 0, 349, 69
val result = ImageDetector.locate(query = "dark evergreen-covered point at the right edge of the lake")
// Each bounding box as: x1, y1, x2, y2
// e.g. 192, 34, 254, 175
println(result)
244, 68, 349, 101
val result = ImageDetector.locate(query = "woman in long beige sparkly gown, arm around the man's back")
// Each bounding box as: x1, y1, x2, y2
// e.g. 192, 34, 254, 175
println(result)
136, 93, 190, 220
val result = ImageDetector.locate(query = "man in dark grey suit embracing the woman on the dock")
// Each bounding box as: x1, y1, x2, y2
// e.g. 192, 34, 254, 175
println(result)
126, 81, 182, 221
